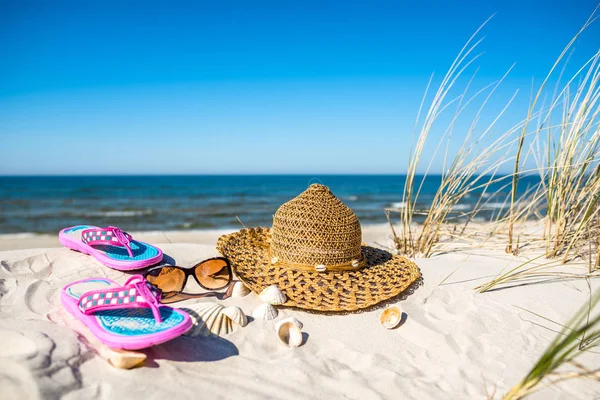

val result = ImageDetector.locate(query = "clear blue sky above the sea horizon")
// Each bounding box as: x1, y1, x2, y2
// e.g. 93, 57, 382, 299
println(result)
0, 0, 600, 174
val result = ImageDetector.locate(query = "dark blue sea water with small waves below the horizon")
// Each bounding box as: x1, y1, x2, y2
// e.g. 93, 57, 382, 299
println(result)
0, 175, 539, 233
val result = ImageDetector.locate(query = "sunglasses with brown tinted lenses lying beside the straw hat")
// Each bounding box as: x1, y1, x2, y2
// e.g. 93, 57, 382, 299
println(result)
144, 257, 233, 303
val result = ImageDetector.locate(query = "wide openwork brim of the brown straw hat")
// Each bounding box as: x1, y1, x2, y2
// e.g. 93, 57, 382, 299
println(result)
217, 228, 421, 311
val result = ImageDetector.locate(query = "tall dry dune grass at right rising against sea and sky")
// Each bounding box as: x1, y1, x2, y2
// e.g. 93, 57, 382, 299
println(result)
394, 9, 600, 268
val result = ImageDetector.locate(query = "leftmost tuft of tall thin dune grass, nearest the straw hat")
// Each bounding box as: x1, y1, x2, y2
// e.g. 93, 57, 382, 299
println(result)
387, 21, 520, 257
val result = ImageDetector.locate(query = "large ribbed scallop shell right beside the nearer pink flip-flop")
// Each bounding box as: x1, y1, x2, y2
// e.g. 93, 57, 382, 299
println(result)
181, 302, 233, 336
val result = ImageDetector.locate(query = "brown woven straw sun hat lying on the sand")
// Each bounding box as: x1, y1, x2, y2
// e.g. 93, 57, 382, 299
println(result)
217, 184, 421, 311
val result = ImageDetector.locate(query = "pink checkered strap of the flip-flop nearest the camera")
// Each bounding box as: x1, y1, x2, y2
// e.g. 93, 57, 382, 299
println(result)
78, 275, 162, 323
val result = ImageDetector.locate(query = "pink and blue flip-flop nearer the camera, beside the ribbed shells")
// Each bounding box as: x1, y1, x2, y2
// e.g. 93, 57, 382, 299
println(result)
60, 275, 192, 350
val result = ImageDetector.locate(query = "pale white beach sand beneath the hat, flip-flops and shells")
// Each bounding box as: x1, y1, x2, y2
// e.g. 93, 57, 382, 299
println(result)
0, 230, 600, 399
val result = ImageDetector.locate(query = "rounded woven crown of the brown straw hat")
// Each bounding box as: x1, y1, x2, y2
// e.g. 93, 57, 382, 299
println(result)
271, 184, 362, 266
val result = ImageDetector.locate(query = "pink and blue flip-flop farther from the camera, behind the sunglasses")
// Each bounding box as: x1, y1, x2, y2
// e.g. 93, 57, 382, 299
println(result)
58, 225, 163, 271
